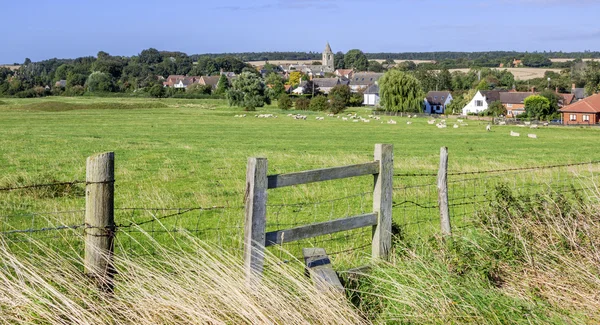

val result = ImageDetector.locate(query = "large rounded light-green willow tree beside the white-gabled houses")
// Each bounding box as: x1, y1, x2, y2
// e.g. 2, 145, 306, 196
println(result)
379, 69, 425, 112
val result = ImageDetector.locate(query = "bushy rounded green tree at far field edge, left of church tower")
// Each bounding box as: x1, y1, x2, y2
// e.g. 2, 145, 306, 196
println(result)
227, 72, 267, 111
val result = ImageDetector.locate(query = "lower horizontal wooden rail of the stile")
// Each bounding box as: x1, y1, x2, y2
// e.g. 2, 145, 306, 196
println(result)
265, 213, 377, 247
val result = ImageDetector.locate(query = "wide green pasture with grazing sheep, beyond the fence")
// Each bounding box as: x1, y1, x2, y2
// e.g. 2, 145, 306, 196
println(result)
0, 98, 600, 260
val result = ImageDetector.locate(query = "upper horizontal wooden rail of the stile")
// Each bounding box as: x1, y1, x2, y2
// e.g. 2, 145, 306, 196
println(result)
268, 161, 379, 188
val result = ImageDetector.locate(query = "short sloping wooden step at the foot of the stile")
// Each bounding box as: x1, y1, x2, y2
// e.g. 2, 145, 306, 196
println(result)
302, 248, 345, 294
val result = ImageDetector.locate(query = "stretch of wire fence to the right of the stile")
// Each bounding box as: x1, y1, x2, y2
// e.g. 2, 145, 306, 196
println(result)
393, 161, 600, 237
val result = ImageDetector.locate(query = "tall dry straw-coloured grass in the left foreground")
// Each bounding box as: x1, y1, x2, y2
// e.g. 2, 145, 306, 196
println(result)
0, 233, 366, 324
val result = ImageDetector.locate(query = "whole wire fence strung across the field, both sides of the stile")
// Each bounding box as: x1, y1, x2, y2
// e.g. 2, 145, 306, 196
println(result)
0, 161, 600, 265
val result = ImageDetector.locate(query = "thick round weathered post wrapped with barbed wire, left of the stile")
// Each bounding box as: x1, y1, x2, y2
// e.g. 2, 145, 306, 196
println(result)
84, 152, 115, 292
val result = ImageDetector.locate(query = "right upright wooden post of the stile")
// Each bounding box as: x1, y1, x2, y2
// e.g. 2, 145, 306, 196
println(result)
371, 144, 394, 260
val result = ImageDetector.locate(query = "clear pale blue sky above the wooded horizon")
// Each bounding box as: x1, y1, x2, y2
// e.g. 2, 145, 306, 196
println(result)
0, 0, 600, 63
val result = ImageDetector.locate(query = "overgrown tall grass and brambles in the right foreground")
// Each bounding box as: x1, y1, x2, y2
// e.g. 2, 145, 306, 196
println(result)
353, 186, 600, 324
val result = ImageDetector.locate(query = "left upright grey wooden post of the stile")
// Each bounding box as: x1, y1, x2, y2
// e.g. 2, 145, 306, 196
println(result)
244, 158, 268, 279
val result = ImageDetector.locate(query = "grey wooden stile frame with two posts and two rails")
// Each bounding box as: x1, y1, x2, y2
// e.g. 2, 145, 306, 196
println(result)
244, 144, 394, 278
